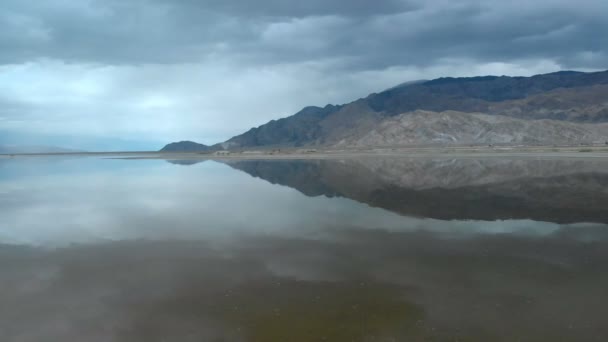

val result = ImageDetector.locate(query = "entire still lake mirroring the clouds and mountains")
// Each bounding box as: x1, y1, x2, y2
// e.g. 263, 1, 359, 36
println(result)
0, 158, 608, 342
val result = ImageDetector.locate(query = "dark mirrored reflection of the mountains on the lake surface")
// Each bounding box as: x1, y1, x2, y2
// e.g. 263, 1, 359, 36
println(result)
226, 158, 608, 223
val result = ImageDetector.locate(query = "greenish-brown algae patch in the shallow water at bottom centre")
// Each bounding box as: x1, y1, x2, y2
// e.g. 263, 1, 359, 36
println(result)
218, 281, 423, 342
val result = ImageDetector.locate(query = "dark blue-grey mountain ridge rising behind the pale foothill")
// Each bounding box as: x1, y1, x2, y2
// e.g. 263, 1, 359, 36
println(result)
160, 71, 608, 150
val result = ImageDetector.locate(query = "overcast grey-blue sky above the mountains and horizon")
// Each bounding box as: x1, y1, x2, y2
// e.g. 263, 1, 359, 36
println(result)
0, 0, 608, 151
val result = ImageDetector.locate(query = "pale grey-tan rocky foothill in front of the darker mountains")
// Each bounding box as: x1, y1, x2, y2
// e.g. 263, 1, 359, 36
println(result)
332, 110, 608, 147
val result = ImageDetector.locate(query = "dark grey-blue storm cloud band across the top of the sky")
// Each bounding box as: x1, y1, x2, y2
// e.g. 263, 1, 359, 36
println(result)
0, 0, 608, 70
